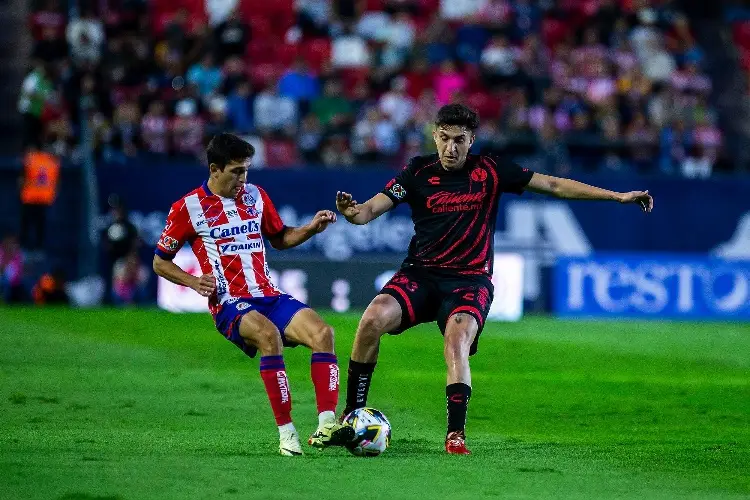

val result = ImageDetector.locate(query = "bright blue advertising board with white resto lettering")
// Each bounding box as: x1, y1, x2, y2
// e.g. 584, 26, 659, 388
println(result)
553, 254, 750, 320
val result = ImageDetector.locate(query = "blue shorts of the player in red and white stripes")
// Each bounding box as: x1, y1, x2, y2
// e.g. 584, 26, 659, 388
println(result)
214, 294, 309, 358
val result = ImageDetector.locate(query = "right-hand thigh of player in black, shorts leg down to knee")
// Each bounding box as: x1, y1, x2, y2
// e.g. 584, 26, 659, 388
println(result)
437, 280, 493, 355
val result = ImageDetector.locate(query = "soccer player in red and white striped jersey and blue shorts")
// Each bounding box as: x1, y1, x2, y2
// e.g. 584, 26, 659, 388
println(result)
154, 134, 341, 456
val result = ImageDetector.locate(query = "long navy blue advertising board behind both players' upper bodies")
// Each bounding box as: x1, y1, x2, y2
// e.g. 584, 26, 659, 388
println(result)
97, 162, 750, 309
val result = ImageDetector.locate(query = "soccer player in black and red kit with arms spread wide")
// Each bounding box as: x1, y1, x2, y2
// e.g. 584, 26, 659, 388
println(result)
333, 104, 653, 455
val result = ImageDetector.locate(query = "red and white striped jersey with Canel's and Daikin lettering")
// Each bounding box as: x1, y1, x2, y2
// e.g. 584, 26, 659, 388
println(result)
156, 182, 284, 311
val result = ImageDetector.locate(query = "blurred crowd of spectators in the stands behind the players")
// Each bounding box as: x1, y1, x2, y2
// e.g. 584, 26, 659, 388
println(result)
19, 0, 736, 177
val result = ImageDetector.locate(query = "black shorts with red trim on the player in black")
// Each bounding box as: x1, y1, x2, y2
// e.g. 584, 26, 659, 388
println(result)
380, 267, 494, 356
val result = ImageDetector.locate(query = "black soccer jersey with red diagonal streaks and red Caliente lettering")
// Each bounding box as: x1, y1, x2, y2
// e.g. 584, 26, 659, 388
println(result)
383, 154, 533, 276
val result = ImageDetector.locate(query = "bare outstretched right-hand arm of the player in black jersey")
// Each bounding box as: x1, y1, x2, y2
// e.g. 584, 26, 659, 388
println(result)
526, 173, 654, 212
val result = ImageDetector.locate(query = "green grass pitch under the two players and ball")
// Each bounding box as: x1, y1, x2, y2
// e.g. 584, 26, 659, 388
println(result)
0, 308, 750, 500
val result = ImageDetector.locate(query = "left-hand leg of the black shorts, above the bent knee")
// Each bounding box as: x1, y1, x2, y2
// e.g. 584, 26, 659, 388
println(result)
378, 269, 439, 335
